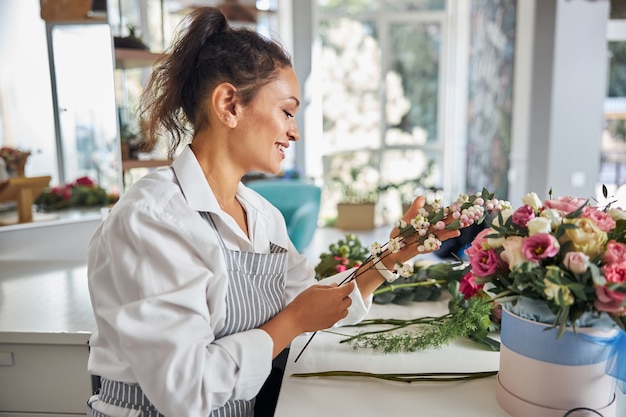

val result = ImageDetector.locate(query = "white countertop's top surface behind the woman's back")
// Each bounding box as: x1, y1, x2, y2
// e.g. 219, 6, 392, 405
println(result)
0, 260, 95, 344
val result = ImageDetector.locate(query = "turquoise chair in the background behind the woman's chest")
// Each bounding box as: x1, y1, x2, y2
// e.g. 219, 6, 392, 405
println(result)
246, 179, 322, 252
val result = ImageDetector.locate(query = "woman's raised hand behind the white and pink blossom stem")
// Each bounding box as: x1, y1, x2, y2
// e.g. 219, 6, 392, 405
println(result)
381, 196, 461, 270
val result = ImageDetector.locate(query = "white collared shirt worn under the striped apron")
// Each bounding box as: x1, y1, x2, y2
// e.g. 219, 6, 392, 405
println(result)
88, 147, 371, 417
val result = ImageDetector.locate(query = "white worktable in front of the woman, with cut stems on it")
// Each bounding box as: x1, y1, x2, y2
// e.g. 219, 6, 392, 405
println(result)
275, 301, 509, 417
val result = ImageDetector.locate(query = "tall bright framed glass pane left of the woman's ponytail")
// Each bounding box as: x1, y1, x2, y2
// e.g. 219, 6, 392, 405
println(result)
47, 23, 122, 193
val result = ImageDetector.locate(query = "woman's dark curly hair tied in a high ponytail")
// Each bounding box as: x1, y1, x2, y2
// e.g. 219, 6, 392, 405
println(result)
140, 7, 292, 157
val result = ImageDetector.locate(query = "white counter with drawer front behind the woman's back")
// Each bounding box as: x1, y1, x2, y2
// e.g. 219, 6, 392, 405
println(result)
0, 260, 95, 417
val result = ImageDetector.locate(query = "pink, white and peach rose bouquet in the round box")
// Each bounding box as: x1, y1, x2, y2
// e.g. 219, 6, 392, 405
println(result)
464, 190, 626, 336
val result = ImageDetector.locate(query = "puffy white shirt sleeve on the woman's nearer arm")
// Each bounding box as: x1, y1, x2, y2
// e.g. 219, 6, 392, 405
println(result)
90, 200, 273, 417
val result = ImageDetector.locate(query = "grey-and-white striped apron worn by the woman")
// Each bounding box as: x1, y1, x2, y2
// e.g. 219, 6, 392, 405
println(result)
87, 213, 287, 417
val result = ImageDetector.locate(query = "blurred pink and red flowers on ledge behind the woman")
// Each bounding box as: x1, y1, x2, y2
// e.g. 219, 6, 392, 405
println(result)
34, 177, 117, 211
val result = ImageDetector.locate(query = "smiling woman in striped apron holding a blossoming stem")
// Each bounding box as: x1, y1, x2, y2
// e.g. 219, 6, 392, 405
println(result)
88, 8, 457, 417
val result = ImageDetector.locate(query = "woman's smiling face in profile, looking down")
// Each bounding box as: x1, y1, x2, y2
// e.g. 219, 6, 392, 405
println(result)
230, 67, 300, 174
